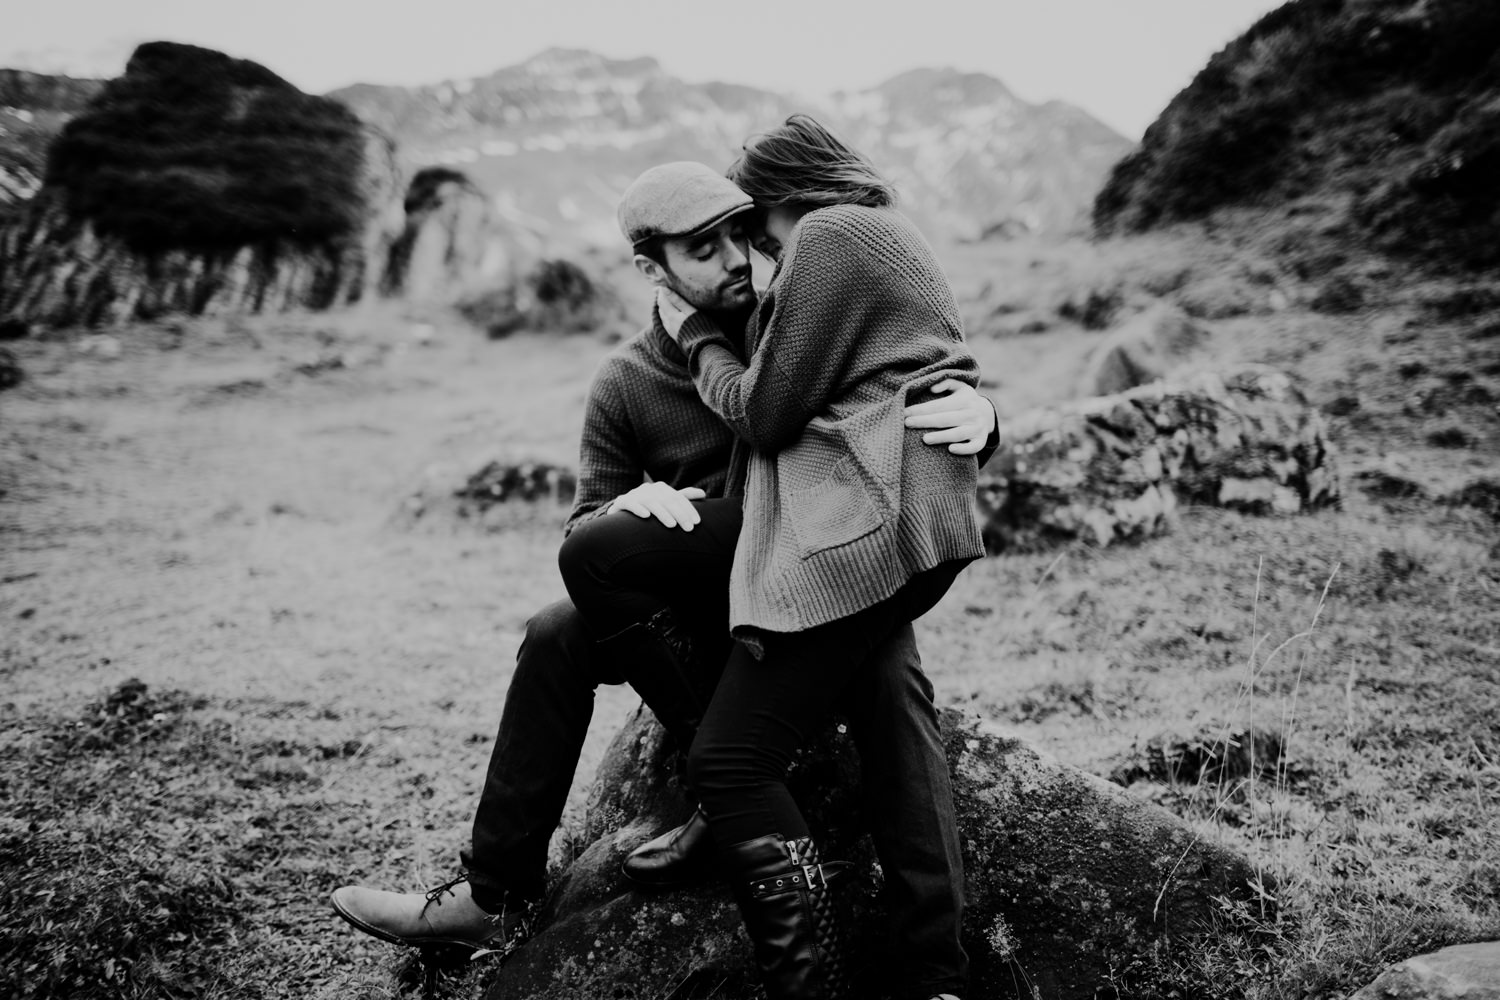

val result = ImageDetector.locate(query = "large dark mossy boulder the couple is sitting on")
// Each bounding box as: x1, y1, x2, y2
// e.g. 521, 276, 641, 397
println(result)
486, 709, 1265, 1000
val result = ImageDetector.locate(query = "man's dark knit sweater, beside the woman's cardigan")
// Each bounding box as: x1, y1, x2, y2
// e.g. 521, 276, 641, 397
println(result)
564, 312, 735, 532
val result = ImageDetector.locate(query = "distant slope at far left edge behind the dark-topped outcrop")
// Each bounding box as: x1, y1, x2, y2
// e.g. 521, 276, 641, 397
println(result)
0, 69, 104, 211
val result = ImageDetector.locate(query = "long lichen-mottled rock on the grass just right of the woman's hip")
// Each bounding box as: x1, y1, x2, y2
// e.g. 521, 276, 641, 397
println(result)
980, 366, 1340, 552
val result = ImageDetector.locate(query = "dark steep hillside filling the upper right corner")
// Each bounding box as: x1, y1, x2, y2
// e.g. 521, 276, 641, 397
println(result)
1094, 0, 1500, 271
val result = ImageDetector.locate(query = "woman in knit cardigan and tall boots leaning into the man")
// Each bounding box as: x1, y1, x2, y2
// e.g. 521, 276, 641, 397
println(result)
561, 115, 983, 1000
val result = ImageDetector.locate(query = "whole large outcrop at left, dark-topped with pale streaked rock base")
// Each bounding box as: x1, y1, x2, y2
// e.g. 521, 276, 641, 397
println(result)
0, 43, 401, 325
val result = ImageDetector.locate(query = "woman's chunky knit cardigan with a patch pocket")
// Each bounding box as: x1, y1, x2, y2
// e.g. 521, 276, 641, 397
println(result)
678, 205, 984, 648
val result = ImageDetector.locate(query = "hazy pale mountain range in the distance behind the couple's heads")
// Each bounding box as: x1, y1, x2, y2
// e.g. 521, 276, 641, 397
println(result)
329, 48, 1130, 243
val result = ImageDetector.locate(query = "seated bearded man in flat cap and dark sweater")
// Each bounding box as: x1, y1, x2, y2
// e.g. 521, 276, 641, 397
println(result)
333, 163, 995, 997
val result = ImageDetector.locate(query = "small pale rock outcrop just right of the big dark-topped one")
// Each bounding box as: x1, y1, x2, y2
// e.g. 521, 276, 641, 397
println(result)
381, 166, 515, 301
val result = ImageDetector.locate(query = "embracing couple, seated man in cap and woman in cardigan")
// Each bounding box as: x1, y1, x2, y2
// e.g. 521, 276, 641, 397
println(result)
333, 115, 995, 1000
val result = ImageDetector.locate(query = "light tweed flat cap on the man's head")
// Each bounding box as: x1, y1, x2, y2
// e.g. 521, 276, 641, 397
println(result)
615, 160, 755, 246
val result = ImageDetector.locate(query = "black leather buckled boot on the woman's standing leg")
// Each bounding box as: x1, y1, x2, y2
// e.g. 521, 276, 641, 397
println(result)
720, 834, 849, 1000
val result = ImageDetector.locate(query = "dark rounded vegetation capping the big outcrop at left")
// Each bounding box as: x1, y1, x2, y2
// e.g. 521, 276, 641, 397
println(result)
47, 42, 363, 252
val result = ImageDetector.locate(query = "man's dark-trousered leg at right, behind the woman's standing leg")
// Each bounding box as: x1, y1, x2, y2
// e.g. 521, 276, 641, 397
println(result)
846, 624, 969, 1000
